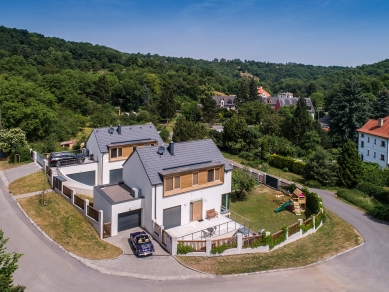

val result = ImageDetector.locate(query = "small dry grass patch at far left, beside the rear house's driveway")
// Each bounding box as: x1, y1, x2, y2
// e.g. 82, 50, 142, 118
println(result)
8, 170, 51, 196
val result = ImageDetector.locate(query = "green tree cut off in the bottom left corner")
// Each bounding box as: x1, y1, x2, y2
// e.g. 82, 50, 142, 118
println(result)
0, 230, 26, 292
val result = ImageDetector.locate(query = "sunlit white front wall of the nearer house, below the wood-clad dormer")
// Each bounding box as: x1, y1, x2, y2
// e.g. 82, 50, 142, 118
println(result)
156, 171, 232, 225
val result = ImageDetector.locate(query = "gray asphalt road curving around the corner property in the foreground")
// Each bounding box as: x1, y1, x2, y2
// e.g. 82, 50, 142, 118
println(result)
0, 163, 389, 292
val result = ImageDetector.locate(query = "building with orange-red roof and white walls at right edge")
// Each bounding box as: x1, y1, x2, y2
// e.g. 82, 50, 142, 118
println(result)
357, 116, 389, 168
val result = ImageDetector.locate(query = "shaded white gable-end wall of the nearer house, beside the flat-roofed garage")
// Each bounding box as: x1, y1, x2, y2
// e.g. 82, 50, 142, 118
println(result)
123, 152, 154, 232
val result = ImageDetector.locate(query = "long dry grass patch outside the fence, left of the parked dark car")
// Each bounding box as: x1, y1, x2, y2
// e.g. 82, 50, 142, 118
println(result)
18, 192, 122, 260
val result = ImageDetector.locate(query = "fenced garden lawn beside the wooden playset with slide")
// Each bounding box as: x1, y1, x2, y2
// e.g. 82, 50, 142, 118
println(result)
230, 185, 305, 232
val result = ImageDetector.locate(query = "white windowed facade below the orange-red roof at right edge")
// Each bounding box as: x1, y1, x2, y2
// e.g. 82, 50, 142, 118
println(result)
358, 133, 389, 168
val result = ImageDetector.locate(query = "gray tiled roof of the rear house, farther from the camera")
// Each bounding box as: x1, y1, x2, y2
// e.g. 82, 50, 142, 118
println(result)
91, 124, 163, 153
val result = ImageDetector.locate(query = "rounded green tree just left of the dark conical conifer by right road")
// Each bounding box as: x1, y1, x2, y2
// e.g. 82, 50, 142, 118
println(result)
302, 147, 338, 186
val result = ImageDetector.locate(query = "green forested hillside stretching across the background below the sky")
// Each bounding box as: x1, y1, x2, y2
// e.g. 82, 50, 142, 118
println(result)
0, 26, 389, 148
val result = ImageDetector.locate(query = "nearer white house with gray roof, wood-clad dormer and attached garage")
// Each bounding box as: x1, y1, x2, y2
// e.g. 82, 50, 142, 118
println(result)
93, 139, 232, 235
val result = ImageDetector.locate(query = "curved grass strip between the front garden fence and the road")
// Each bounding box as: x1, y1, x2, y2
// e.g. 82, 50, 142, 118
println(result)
177, 211, 363, 275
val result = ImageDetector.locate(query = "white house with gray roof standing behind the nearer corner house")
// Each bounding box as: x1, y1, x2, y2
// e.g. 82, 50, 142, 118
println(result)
79, 124, 163, 185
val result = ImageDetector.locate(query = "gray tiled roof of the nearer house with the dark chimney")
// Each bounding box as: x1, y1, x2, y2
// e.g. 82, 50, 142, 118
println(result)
134, 139, 232, 185
